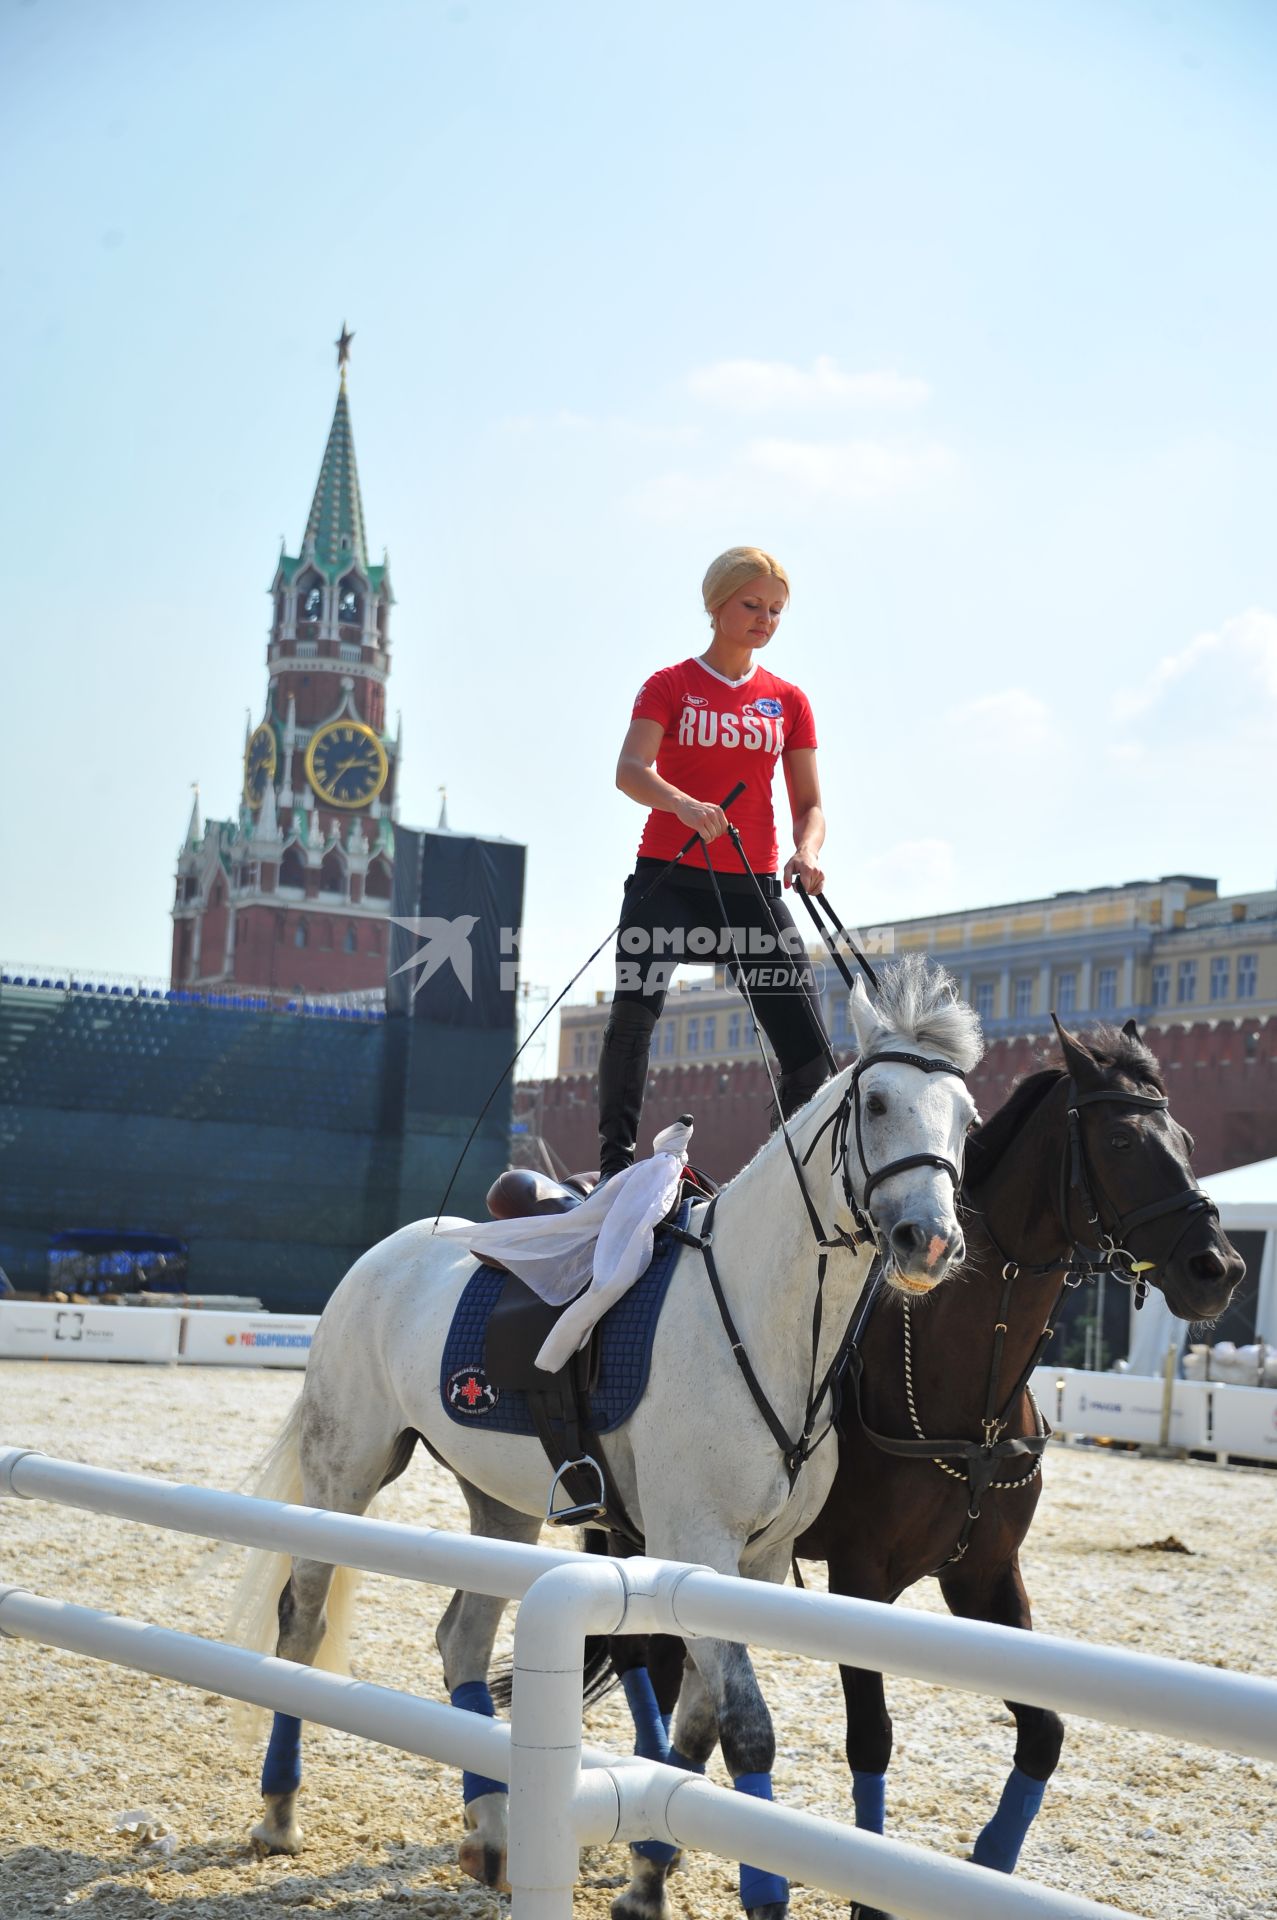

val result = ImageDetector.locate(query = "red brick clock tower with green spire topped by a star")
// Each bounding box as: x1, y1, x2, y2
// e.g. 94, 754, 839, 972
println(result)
173, 326, 401, 995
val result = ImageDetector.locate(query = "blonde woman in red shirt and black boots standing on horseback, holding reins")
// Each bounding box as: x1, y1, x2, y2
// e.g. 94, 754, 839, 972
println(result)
599, 547, 830, 1179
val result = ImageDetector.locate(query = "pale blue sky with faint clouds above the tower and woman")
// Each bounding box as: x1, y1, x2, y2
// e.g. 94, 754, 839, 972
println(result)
0, 0, 1277, 1067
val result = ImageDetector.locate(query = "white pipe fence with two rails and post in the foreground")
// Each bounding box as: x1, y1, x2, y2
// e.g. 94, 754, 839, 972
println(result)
0, 1448, 1277, 1920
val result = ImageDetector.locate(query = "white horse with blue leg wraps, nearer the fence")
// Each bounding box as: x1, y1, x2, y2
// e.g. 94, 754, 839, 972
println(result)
236, 956, 981, 1916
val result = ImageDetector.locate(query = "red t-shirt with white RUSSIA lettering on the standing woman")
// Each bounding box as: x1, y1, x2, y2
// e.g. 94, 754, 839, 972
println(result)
634, 659, 816, 874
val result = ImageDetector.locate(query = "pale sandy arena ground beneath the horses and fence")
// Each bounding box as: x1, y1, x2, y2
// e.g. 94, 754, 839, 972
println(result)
0, 1361, 1277, 1920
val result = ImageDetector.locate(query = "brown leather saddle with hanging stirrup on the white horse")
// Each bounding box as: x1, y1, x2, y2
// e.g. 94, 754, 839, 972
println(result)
484, 1167, 718, 1551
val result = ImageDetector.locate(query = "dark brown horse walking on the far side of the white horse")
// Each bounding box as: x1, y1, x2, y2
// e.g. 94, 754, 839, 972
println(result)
599, 1021, 1246, 1920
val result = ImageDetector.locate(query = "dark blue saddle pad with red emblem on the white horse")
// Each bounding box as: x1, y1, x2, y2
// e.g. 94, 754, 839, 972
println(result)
440, 1200, 691, 1434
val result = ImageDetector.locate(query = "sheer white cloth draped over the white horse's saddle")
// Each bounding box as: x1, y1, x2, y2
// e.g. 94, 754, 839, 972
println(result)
440, 1121, 691, 1373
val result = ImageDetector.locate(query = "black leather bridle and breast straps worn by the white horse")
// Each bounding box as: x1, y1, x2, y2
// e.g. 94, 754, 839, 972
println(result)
676, 1046, 966, 1490
